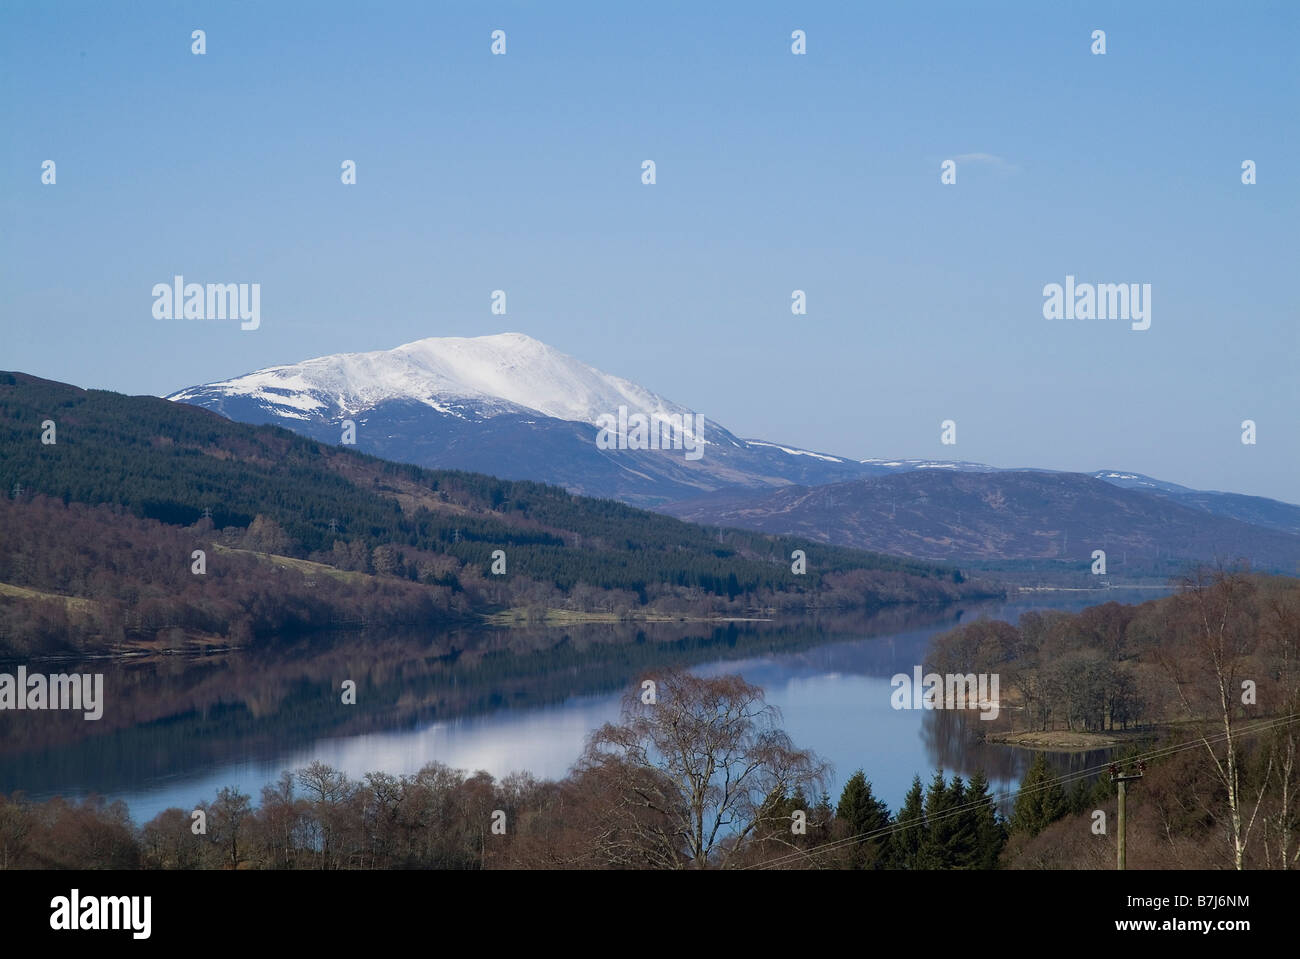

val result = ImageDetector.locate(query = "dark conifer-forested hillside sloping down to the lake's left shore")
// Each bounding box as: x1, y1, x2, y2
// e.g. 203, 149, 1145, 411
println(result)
0, 373, 995, 655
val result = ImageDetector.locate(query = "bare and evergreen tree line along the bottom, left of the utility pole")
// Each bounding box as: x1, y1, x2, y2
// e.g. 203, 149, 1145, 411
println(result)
0, 671, 1123, 869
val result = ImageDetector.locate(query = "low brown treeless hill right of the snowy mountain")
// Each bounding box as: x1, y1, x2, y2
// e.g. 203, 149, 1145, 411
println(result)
666, 470, 1300, 573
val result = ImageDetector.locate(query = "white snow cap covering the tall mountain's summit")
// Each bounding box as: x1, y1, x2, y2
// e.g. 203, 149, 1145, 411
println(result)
168, 333, 690, 424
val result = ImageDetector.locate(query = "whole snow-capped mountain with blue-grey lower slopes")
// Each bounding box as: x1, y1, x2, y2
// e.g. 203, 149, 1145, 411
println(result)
168, 333, 872, 505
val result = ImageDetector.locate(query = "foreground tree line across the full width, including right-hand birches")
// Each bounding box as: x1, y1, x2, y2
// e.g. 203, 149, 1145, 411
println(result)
0, 605, 1300, 869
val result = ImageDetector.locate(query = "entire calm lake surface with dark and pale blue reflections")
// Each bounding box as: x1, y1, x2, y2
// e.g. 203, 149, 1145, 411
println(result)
0, 590, 1160, 823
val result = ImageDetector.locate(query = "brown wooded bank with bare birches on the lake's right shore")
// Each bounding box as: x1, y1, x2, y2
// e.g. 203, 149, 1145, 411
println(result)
927, 568, 1300, 869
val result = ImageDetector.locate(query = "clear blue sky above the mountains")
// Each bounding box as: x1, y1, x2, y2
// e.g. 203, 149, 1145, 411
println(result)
0, 0, 1300, 502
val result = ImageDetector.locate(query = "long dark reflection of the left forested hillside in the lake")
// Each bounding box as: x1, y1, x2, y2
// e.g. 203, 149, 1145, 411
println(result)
0, 607, 993, 794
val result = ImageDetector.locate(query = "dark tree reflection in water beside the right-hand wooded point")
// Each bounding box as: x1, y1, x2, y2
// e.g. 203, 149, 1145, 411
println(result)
918, 710, 1113, 812
